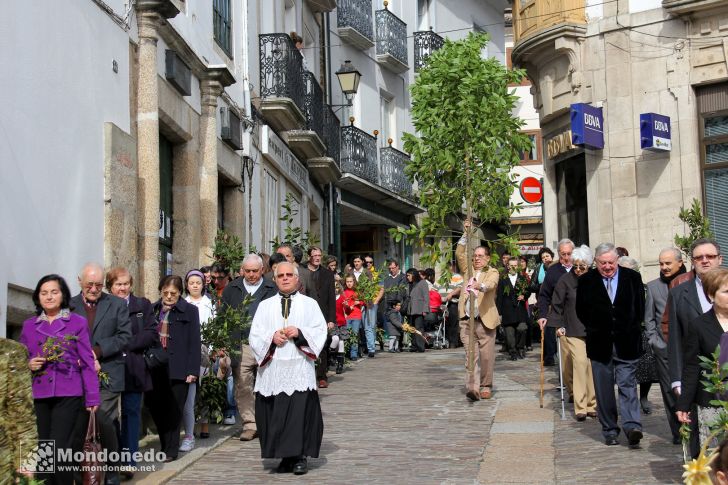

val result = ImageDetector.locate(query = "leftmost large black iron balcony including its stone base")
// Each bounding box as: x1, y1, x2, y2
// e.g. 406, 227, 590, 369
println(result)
259, 34, 306, 132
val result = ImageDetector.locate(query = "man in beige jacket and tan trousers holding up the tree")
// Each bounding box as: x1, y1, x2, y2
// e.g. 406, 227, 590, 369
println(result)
455, 242, 500, 401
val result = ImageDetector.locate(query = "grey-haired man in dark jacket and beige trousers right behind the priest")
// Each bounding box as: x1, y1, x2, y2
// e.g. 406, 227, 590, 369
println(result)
222, 253, 278, 441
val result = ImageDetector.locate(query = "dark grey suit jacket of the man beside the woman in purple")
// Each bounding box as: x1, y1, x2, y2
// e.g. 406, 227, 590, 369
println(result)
71, 293, 131, 392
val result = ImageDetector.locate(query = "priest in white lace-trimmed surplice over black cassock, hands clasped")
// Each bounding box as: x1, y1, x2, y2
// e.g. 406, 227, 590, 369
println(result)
249, 263, 326, 475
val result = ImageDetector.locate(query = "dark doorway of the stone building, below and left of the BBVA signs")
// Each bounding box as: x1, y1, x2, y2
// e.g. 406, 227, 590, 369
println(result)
556, 153, 589, 246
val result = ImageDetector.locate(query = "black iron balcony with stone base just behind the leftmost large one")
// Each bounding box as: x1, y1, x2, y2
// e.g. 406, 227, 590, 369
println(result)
280, 71, 326, 160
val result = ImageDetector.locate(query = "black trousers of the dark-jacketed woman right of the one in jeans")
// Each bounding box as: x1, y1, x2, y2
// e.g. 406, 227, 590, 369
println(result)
144, 366, 189, 458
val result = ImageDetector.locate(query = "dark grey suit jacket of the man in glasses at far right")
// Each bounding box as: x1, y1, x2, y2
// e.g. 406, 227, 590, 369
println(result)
667, 279, 703, 382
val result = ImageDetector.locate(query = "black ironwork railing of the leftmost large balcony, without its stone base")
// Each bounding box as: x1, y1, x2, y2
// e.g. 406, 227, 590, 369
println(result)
259, 34, 306, 112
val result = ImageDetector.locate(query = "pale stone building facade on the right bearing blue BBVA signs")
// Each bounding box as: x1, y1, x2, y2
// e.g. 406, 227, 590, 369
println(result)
513, 0, 728, 278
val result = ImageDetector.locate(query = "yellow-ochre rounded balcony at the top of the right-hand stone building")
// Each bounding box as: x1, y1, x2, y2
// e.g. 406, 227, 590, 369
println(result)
513, 0, 586, 43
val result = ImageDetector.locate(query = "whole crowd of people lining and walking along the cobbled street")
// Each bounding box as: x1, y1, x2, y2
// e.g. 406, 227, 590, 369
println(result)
7, 227, 728, 484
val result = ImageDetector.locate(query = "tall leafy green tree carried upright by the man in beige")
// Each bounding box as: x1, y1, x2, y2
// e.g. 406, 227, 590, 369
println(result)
392, 33, 531, 372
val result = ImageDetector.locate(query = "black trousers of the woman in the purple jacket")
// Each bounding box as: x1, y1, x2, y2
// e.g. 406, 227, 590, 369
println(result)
33, 396, 85, 485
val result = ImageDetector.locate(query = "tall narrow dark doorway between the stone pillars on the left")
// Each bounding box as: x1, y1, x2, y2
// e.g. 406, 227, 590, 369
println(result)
159, 136, 173, 276
